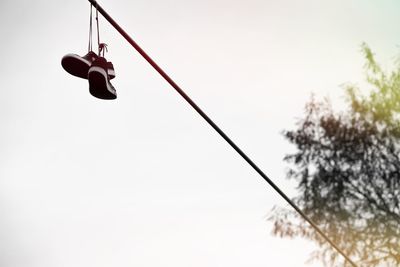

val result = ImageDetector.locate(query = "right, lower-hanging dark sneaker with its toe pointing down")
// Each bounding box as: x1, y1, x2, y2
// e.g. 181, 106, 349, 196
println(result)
88, 57, 117, 99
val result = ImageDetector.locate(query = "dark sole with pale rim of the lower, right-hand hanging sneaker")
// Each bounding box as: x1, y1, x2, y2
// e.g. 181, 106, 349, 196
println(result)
88, 66, 117, 100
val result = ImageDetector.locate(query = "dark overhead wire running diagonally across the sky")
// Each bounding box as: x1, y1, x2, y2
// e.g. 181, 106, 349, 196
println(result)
88, 0, 358, 267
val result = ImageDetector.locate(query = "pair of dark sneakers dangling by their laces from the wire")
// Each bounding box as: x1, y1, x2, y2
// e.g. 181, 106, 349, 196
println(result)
61, 51, 117, 99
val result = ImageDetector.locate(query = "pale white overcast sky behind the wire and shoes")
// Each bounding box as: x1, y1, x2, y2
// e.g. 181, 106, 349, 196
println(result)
0, 0, 400, 267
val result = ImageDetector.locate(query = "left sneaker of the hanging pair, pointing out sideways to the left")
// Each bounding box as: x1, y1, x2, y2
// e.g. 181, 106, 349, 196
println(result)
61, 51, 98, 79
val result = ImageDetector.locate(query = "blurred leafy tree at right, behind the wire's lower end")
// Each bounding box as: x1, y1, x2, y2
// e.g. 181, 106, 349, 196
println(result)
269, 44, 400, 266
